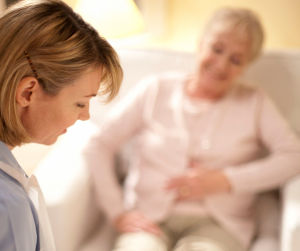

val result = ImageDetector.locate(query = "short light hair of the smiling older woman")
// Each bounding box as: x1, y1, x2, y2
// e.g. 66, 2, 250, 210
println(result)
203, 7, 264, 62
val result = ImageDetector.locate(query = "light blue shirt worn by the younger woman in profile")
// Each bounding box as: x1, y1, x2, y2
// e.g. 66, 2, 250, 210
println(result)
0, 141, 40, 251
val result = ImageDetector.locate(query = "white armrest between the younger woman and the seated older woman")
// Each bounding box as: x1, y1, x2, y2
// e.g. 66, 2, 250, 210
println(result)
36, 121, 101, 251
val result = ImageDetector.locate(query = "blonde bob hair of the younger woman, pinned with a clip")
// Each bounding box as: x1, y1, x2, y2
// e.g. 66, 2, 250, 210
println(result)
0, 0, 123, 146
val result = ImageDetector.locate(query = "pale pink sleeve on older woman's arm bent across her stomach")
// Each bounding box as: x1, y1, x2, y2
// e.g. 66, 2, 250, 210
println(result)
224, 95, 300, 193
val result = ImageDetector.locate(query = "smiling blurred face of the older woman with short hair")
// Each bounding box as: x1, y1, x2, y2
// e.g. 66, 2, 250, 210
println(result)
197, 28, 251, 96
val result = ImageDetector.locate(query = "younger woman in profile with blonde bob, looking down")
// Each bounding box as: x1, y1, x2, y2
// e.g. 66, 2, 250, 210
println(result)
0, 0, 122, 251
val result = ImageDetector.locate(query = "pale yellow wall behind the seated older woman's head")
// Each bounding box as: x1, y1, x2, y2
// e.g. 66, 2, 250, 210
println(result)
65, 0, 300, 51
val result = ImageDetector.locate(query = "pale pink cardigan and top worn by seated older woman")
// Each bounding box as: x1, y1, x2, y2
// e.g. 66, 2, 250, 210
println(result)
85, 73, 300, 247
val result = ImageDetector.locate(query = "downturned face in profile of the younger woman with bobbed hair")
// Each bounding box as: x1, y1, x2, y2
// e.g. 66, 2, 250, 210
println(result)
21, 69, 102, 145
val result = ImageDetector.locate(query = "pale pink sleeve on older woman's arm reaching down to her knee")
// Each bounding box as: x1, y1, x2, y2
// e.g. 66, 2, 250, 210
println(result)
84, 77, 157, 220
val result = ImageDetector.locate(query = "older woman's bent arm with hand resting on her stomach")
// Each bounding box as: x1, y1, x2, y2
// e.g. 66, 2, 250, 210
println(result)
166, 92, 300, 200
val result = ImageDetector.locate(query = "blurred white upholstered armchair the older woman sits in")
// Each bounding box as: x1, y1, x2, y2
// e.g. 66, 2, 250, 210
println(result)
17, 50, 300, 251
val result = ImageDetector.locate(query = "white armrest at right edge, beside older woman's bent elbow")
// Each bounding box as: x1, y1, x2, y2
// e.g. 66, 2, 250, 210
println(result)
281, 175, 300, 251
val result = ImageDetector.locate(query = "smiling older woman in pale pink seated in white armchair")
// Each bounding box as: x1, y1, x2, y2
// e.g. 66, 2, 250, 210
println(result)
86, 8, 300, 251
